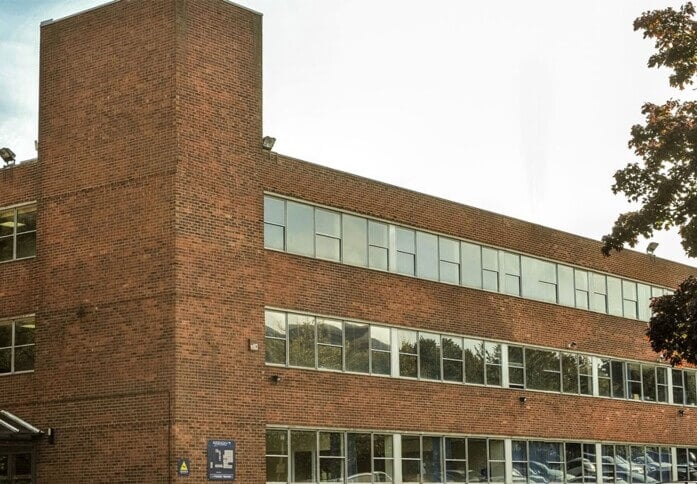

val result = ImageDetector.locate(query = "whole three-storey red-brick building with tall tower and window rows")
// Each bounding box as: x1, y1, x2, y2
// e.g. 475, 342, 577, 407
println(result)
0, 0, 697, 483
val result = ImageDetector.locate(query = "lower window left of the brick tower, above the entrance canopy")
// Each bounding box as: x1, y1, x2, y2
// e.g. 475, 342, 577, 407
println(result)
0, 317, 36, 374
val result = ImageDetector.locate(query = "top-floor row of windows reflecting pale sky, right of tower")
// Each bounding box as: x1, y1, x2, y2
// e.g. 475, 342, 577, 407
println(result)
264, 195, 670, 321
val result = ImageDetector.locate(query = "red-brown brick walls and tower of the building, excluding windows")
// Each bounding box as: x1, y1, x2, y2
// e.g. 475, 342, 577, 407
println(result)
0, 0, 697, 483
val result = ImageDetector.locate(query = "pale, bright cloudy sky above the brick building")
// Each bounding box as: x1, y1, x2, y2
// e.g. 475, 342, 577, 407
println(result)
0, 0, 697, 265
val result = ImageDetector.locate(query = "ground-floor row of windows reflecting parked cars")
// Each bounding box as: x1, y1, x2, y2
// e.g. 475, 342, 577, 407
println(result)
266, 428, 697, 483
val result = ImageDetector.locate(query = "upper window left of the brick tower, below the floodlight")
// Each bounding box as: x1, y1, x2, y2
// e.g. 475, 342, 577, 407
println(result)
0, 205, 36, 262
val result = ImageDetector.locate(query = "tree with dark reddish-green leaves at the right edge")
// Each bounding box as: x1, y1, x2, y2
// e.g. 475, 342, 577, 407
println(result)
602, 2, 697, 364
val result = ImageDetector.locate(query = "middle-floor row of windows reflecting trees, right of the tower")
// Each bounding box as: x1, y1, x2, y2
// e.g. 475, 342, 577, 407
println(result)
265, 310, 697, 406
